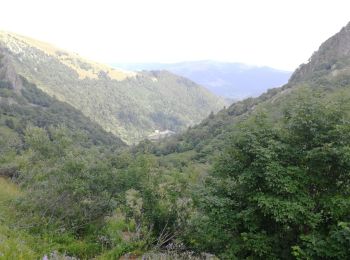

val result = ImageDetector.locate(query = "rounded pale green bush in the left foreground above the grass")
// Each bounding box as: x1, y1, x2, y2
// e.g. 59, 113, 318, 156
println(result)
20, 127, 117, 231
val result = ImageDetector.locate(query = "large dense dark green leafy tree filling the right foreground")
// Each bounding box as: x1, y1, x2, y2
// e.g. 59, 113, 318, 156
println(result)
191, 95, 350, 259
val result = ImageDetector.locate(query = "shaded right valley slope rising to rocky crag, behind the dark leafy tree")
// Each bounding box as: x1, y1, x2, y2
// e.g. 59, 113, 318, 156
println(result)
148, 23, 350, 162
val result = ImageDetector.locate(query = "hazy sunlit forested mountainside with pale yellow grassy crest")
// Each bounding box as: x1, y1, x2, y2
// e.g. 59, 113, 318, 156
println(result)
0, 32, 225, 143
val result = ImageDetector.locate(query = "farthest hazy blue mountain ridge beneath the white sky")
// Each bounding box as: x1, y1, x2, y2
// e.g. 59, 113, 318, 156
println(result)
112, 60, 291, 100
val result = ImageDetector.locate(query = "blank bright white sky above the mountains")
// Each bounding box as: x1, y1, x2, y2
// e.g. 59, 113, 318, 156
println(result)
0, 0, 350, 71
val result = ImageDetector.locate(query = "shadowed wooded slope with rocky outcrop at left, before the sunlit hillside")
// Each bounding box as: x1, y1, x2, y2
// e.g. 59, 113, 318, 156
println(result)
0, 47, 125, 150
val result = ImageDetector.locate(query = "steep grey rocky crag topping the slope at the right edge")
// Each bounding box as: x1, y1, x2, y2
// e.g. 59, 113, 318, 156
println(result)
289, 23, 350, 84
